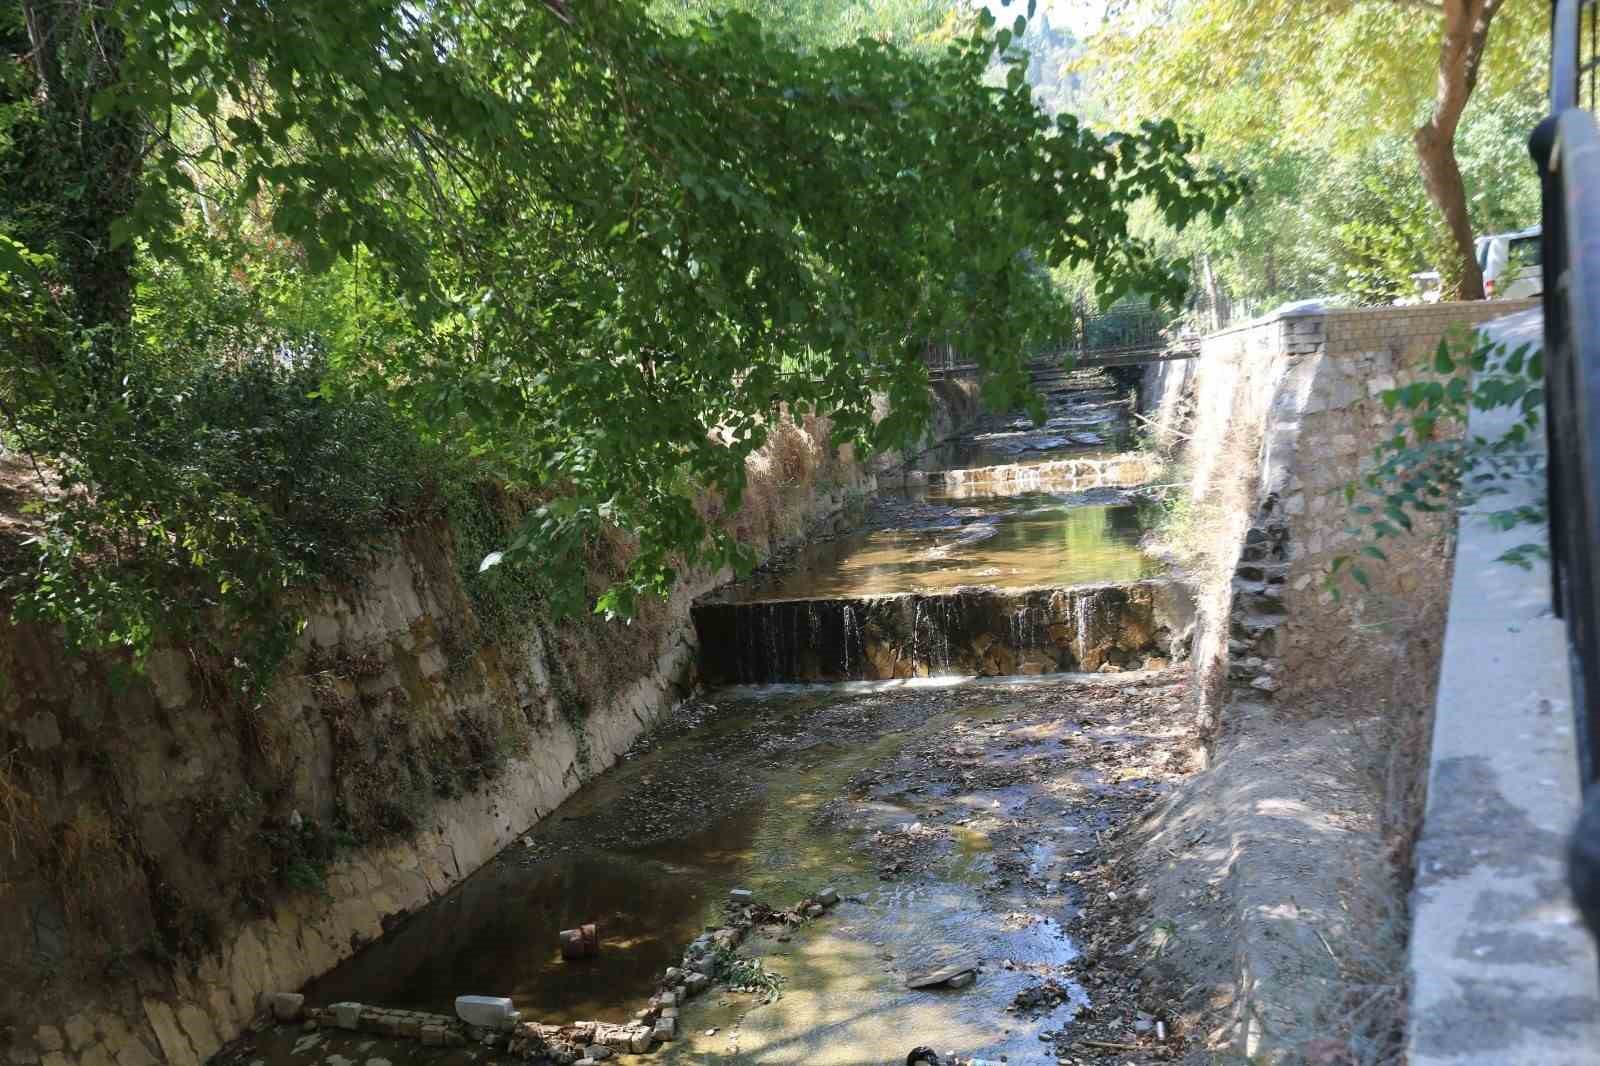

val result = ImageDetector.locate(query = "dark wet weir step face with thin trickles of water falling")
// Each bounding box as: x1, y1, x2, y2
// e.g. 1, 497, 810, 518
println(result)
694, 578, 1194, 685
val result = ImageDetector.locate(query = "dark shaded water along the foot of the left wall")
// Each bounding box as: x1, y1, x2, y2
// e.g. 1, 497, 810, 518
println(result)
304, 699, 928, 1021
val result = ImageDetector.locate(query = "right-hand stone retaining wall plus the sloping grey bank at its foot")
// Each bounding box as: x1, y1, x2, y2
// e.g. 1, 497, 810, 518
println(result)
1141, 294, 1554, 1063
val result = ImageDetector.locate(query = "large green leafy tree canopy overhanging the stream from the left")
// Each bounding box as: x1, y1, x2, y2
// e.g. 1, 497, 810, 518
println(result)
0, 0, 1237, 656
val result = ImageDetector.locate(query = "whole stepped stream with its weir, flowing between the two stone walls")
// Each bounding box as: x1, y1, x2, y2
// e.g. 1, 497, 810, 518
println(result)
219, 375, 1187, 1066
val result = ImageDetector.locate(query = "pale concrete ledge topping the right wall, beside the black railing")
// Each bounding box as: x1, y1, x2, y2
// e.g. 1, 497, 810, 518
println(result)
1406, 311, 1600, 1066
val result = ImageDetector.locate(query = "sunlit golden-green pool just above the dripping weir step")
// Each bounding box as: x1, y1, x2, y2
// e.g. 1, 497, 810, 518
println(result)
726, 493, 1163, 602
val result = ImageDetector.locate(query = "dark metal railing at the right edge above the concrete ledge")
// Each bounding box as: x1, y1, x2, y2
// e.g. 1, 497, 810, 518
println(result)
1530, 0, 1600, 787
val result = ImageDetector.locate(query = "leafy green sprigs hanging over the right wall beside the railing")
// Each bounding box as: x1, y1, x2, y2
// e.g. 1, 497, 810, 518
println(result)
1325, 335, 1546, 597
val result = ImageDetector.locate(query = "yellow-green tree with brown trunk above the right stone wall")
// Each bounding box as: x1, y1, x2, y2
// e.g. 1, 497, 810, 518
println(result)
1094, 0, 1546, 298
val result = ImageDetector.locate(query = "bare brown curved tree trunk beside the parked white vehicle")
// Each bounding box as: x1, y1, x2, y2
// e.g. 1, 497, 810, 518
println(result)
1411, 0, 1501, 299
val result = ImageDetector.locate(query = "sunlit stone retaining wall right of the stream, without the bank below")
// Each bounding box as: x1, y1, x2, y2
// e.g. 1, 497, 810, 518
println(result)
1146, 301, 1531, 735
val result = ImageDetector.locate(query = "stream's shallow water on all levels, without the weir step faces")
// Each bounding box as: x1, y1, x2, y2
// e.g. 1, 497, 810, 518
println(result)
234, 371, 1162, 1066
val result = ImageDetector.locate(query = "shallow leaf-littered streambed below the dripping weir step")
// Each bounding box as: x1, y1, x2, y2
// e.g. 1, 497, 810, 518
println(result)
227, 672, 1186, 1066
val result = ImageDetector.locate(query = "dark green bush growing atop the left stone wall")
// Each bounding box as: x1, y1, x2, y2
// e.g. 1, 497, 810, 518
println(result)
5, 352, 442, 698
